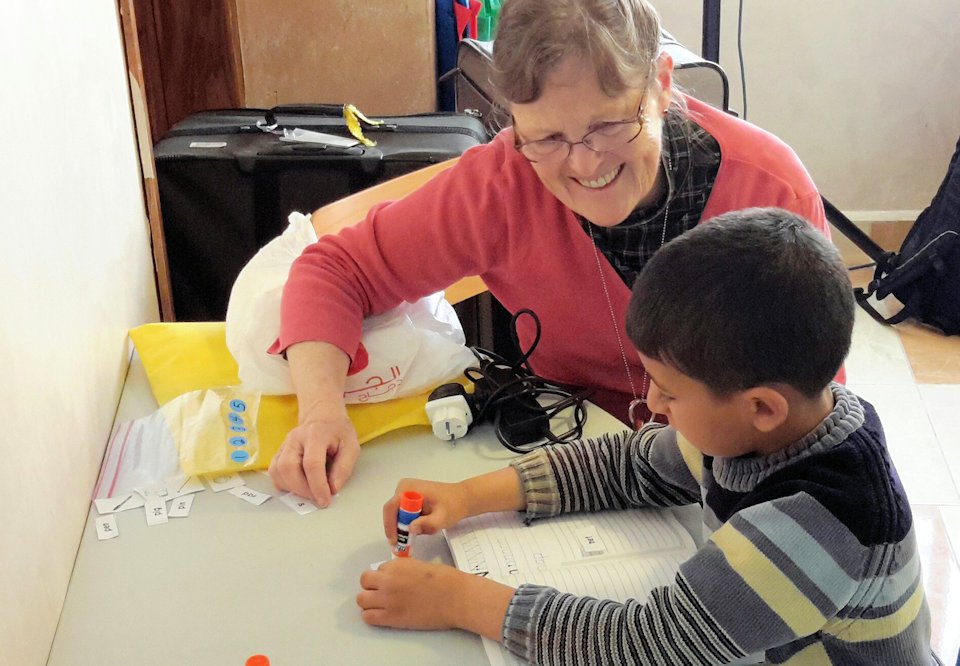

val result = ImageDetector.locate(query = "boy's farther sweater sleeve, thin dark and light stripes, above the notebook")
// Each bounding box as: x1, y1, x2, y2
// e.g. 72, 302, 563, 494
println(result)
510, 424, 702, 518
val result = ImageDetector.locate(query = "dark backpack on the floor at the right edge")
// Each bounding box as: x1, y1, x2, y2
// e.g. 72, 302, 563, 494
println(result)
823, 134, 960, 335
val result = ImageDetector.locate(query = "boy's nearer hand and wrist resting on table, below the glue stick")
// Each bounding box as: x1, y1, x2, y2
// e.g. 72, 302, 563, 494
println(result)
357, 558, 514, 641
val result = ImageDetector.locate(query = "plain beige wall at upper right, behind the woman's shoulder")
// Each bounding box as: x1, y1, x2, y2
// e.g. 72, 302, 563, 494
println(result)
653, 0, 960, 221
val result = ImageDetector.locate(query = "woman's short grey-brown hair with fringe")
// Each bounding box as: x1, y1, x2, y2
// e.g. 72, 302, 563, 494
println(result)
491, 0, 660, 106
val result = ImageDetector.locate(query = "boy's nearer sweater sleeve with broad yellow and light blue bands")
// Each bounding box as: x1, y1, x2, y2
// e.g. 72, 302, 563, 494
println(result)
503, 495, 868, 664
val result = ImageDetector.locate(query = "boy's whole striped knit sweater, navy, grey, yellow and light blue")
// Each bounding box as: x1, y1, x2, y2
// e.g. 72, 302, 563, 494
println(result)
503, 384, 937, 666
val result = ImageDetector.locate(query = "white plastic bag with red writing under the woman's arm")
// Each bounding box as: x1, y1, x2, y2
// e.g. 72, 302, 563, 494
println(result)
226, 213, 476, 403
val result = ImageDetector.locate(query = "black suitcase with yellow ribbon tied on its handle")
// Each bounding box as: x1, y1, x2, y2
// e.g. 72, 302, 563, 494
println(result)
154, 105, 489, 321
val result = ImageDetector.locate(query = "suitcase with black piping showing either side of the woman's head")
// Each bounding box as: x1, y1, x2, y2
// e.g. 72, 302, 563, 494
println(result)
441, 31, 730, 135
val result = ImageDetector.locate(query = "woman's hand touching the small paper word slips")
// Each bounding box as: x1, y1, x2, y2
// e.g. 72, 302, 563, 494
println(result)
268, 404, 360, 507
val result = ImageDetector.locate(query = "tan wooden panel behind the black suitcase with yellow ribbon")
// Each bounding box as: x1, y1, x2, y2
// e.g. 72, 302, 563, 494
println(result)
237, 0, 437, 115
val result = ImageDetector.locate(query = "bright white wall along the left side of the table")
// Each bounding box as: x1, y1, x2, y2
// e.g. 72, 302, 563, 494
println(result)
0, 0, 157, 666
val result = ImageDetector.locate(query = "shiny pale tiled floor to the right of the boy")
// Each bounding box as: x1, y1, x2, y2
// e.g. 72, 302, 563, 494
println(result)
833, 223, 960, 665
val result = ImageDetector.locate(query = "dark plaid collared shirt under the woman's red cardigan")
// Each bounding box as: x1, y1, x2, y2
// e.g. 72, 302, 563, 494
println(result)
578, 111, 720, 287
